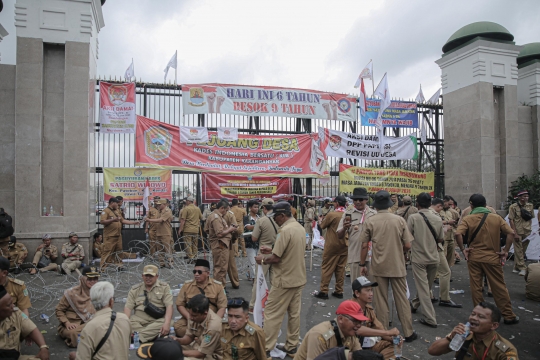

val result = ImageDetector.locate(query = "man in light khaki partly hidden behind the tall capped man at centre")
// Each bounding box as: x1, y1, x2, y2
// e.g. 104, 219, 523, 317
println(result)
249, 198, 276, 311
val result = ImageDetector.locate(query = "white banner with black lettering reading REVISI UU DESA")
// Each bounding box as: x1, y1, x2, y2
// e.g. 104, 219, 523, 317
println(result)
319, 128, 418, 160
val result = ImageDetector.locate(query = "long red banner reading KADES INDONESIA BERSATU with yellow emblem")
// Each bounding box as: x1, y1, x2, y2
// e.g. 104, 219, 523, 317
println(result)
135, 116, 329, 178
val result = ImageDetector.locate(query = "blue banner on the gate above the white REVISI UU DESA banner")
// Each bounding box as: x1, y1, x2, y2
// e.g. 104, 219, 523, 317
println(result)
360, 99, 418, 128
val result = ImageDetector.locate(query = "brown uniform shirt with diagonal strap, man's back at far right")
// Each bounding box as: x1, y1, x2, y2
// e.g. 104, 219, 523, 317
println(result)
457, 214, 514, 265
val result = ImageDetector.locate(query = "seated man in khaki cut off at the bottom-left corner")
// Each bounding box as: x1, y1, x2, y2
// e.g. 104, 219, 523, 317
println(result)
0, 285, 49, 360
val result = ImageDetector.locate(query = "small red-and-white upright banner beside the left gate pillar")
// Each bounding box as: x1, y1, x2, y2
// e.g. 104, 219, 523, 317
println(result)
99, 81, 137, 134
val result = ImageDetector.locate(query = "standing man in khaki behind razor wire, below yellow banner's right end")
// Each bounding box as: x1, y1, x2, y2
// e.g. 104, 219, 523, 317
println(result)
146, 199, 174, 269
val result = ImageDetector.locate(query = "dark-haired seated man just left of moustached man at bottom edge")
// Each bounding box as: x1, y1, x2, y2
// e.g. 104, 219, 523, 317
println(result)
173, 294, 223, 360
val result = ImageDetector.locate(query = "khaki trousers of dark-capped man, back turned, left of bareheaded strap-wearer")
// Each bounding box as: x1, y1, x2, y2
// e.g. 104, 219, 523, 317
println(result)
373, 276, 413, 337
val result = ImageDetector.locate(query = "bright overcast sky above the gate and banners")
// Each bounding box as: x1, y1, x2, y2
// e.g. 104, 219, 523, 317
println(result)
0, 0, 540, 98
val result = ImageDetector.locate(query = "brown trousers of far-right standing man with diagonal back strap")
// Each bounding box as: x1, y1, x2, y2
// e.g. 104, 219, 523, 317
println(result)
467, 260, 516, 320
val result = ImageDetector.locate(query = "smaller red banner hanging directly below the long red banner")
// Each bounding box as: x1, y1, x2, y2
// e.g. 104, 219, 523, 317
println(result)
202, 173, 292, 204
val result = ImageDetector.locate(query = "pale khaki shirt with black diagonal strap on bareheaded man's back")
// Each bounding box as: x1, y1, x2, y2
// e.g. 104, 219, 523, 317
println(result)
407, 209, 444, 265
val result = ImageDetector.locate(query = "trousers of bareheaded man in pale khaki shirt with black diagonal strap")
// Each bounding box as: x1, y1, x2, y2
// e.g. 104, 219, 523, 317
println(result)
411, 262, 440, 325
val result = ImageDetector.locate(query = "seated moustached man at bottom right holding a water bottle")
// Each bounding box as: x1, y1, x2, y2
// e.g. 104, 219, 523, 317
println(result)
428, 302, 518, 360
